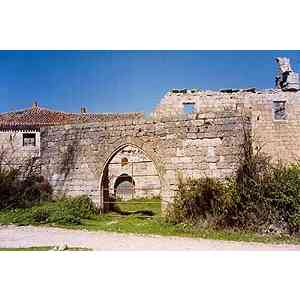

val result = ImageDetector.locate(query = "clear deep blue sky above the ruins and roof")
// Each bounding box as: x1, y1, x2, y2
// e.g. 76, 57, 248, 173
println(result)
0, 51, 300, 112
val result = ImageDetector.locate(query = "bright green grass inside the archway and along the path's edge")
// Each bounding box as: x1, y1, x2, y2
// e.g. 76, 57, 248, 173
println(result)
0, 198, 300, 248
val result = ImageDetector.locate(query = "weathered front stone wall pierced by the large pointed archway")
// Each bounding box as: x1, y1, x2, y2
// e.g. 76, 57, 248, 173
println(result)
41, 109, 246, 211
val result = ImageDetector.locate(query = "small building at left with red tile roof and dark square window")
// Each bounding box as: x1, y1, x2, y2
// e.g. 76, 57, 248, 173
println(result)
0, 101, 144, 165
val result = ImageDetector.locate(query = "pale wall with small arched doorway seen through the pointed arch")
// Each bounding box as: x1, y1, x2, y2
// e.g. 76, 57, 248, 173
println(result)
100, 144, 162, 212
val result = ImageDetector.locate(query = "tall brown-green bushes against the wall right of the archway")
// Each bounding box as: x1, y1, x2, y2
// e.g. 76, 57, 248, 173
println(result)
166, 123, 300, 234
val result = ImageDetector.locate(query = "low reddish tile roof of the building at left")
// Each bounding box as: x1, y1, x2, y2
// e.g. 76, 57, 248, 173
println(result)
0, 104, 143, 130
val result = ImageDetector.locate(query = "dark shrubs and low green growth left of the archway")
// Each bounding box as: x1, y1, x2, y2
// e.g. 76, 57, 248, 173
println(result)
0, 151, 97, 225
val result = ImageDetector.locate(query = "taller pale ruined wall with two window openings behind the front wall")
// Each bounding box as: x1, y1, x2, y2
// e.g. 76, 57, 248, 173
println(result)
153, 89, 300, 161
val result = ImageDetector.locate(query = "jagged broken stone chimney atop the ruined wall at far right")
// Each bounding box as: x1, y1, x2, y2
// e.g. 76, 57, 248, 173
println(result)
275, 57, 300, 91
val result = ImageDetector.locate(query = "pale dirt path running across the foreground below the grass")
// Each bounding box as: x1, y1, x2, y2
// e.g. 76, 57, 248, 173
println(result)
0, 225, 300, 250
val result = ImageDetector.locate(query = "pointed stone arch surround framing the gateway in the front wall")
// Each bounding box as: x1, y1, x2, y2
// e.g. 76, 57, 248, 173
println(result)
98, 136, 170, 212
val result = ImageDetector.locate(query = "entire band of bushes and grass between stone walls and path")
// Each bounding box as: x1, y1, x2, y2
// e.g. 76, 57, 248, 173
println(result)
0, 125, 300, 243
